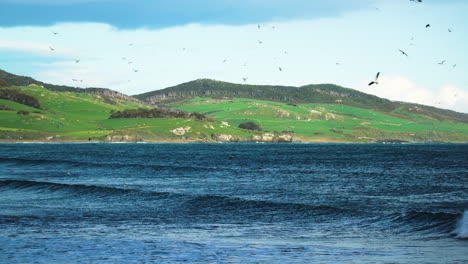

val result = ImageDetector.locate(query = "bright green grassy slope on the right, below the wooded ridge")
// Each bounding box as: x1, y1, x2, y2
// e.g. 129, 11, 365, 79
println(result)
169, 97, 468, 142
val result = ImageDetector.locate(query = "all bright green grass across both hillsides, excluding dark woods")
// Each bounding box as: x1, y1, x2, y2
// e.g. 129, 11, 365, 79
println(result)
0, 86, 468, 142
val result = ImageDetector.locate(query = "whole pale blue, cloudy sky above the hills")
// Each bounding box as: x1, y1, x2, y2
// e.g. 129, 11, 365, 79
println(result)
0, 0, 468, 113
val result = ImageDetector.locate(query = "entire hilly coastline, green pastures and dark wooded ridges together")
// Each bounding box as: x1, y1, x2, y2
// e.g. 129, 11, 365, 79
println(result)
0, 71, 468, 142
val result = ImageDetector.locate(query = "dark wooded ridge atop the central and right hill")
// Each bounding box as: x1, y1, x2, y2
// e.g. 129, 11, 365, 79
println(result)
134, 79, 468, 123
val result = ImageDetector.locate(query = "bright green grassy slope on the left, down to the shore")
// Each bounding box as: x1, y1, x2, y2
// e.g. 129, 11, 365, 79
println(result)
0, 85, 264, 142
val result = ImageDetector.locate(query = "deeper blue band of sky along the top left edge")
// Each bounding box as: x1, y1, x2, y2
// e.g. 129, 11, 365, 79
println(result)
0, 0, 368, 29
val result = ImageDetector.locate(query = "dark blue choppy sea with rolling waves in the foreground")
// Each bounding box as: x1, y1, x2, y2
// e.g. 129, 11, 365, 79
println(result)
0, 144, 468, 264
